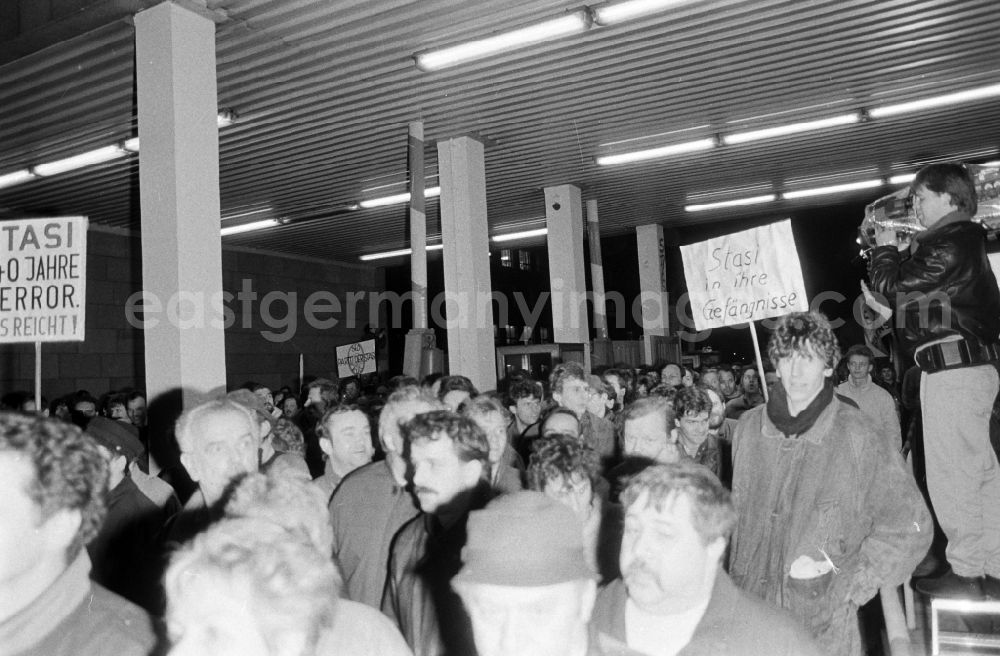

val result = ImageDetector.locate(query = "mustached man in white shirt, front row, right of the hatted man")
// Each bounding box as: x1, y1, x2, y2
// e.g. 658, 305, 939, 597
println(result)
592, 461, 820, 656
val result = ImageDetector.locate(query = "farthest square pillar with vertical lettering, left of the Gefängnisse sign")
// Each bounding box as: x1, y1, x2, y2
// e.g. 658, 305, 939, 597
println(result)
635, 224, 670, 364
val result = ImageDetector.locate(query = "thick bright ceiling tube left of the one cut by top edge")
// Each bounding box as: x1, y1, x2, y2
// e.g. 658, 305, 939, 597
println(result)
415, 10, 590, 71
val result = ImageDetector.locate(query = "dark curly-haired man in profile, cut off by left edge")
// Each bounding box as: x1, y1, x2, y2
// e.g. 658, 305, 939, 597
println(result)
0, 413, 156, 656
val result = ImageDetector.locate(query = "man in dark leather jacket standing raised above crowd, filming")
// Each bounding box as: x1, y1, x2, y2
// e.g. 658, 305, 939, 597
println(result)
869, 163, 1000, 598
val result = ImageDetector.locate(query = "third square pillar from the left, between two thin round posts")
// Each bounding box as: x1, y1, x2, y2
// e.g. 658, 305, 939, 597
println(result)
545, 185, 590, 344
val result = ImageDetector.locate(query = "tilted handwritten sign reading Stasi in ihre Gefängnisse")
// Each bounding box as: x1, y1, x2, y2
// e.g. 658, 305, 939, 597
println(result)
681, 220, 809, 330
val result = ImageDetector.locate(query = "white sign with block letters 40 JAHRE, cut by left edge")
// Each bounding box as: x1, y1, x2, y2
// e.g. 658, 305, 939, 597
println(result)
0, 216, 87, 343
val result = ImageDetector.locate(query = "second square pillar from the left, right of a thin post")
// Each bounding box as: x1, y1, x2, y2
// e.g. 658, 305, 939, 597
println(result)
442, 137, 497, 390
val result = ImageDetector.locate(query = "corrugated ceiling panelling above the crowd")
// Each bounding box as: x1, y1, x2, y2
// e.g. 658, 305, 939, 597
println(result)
0, 0, 1000, 261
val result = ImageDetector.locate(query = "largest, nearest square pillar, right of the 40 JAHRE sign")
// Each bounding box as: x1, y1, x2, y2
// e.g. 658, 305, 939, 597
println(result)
135, 2, 226, 406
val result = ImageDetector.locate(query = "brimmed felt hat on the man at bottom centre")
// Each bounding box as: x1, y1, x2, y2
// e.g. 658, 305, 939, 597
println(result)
454, 490, 595, 587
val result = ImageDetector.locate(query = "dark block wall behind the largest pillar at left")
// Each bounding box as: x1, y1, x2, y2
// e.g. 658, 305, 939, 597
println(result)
0, 226, 384, 400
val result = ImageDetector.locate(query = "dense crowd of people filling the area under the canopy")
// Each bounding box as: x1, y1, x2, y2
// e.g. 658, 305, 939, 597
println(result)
0, 161, 1000, 656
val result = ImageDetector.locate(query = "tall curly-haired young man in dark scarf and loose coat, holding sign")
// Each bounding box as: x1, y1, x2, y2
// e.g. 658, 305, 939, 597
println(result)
729, 312, 933, 656
